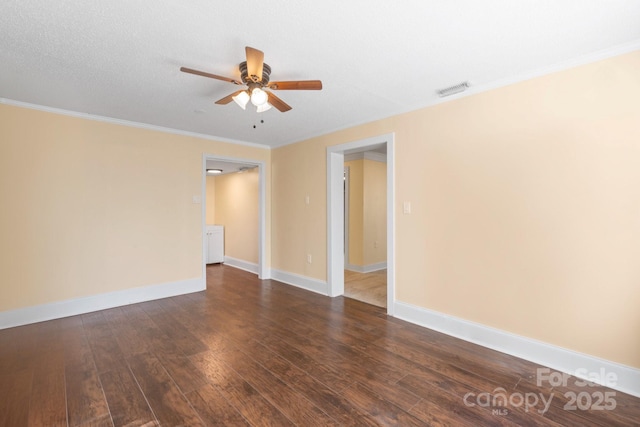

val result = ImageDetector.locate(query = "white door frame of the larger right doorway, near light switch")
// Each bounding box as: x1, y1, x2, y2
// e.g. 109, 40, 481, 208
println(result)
327, 133, 396, 316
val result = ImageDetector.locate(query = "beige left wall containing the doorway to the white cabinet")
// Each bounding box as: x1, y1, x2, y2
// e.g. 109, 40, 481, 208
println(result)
0, 105, 270, 311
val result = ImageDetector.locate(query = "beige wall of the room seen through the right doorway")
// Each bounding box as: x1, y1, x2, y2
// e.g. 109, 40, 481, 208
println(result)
344, 159, 387, 267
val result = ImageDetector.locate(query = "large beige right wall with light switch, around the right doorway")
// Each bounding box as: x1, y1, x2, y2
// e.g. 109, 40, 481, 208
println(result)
272, 52, 640, 367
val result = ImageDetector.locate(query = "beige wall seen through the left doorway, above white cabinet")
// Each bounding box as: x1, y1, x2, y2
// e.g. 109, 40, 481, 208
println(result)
215, 168, 260, 264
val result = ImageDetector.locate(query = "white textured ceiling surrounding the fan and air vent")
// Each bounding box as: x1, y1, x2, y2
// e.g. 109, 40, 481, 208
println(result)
0, 0, 640, 147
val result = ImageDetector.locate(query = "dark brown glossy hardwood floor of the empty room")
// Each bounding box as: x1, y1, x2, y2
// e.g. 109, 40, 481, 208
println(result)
0, 265, 640, 427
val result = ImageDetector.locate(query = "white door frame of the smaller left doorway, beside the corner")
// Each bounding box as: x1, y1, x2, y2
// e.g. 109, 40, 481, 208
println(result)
201, 154, 271, 280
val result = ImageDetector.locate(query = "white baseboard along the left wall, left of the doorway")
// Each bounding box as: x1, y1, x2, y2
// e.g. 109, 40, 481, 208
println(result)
0, 277, 207, 329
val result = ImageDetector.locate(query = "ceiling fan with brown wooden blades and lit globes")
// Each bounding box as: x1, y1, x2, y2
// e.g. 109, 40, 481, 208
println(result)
180, 46, 322, 113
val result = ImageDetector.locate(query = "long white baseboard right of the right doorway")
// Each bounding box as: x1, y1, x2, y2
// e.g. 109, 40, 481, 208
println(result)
394, 301, 640, 397
